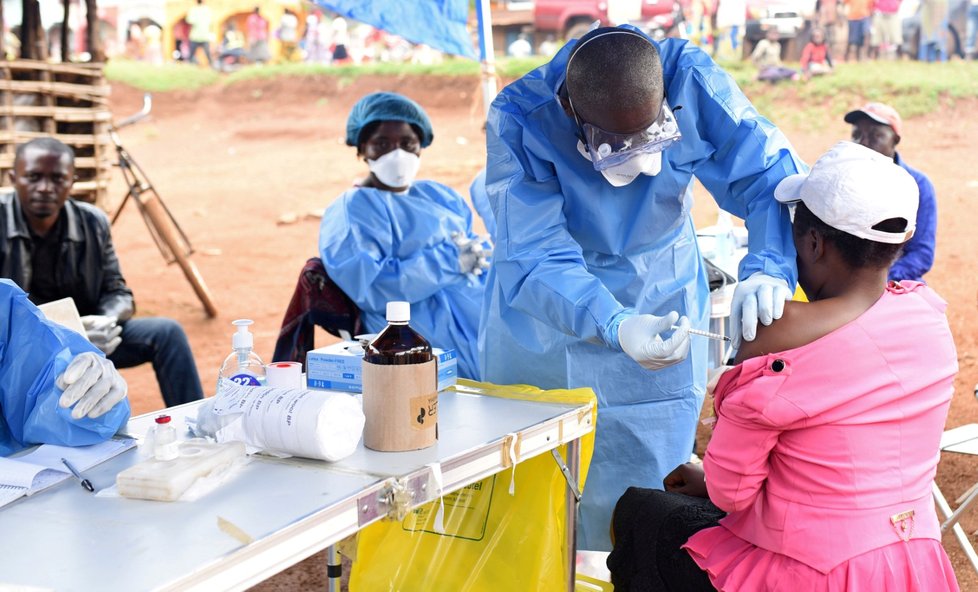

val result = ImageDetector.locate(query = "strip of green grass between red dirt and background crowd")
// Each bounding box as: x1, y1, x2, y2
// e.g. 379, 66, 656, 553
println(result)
106, 58, 978, 123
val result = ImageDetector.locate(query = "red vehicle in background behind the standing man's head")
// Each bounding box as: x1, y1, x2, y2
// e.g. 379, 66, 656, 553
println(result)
533, 0, 675, 40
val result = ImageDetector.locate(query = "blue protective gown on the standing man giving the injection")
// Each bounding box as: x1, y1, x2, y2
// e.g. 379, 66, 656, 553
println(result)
480, 31, 804, 550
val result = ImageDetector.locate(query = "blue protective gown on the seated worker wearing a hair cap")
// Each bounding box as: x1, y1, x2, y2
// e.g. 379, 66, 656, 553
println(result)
319, 181, 486, 379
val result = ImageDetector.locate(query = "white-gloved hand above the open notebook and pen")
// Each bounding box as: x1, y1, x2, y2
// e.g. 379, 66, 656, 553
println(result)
56, 352, 128, 419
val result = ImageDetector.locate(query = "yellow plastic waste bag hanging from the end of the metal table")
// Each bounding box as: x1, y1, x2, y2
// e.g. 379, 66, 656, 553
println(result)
350, 380, 597, 592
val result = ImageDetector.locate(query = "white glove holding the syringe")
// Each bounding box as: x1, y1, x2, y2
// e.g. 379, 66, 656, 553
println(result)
618, 311, 689, 370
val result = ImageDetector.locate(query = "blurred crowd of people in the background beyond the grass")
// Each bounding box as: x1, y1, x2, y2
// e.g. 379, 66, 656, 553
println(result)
108, 0, 978, 73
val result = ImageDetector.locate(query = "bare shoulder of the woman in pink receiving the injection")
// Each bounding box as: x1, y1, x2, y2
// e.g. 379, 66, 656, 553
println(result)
735, 300, 832, 364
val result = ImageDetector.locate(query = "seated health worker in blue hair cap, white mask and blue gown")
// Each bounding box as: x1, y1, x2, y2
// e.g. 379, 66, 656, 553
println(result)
319, 92, 491, 378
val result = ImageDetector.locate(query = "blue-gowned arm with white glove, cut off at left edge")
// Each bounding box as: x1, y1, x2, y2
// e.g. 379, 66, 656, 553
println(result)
0, 279, 129, 456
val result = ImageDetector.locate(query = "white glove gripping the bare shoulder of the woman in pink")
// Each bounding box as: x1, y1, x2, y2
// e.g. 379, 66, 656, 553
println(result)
730, 273, 792, 350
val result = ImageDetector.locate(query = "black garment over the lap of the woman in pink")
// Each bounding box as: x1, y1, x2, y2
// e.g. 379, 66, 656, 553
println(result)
608, 487, 725, 592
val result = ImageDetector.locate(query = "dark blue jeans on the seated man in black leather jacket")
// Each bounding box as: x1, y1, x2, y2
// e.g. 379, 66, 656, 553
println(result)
109, 318, 204, 407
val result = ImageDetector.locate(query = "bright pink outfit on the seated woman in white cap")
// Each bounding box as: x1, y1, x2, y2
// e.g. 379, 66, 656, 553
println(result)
684, 282, 958, 592
